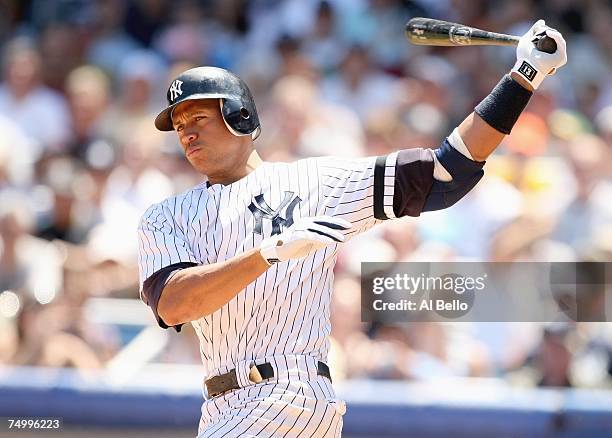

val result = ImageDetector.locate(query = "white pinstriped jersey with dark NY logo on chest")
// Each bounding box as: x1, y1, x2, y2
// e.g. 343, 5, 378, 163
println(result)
139, 153, 397, 376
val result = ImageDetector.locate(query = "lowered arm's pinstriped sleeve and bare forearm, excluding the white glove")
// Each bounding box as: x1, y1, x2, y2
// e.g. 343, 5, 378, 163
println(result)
138, 203, 269, 330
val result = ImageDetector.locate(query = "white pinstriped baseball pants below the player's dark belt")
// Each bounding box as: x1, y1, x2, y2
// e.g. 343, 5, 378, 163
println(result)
198, 356, 346, 438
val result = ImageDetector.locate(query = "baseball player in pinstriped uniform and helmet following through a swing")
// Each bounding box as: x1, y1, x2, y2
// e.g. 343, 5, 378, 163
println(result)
139, 20, 566, 438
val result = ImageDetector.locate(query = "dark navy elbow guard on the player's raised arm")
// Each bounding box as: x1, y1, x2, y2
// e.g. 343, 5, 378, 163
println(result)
423, 139, 485, 211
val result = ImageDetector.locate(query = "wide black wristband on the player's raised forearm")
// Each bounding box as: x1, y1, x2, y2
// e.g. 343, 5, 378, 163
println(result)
474, 74, 533, 134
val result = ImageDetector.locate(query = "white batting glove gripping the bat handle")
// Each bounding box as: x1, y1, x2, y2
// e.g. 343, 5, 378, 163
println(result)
512, 20, 567, 90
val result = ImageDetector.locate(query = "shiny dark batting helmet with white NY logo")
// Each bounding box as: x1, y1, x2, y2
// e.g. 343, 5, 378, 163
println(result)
155, 67, 260, 139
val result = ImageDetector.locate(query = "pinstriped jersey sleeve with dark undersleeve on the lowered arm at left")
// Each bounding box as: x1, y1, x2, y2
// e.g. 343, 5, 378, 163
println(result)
138, 204, 198, 331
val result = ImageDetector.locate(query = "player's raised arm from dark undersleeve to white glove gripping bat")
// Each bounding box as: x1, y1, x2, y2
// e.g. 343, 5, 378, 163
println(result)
394, 20, 567, 219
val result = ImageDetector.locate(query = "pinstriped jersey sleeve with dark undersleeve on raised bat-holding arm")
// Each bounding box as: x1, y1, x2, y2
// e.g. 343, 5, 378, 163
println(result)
317, 148, 434, 240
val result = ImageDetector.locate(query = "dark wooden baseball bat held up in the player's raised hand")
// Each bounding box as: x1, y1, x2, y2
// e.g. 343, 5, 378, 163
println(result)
406, 17, 557, 53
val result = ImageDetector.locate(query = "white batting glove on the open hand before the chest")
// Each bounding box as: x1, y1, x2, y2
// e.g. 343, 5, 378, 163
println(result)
260, 216, 352, 264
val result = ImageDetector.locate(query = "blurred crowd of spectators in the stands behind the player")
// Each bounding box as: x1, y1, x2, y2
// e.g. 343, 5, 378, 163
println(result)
0, 0, 612, 387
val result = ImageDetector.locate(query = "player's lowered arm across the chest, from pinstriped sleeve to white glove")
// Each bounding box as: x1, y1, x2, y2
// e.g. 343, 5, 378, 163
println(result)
138, 203, 350, 330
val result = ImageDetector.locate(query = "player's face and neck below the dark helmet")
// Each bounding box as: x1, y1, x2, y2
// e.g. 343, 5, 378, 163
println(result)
172, 99, 252, 182
